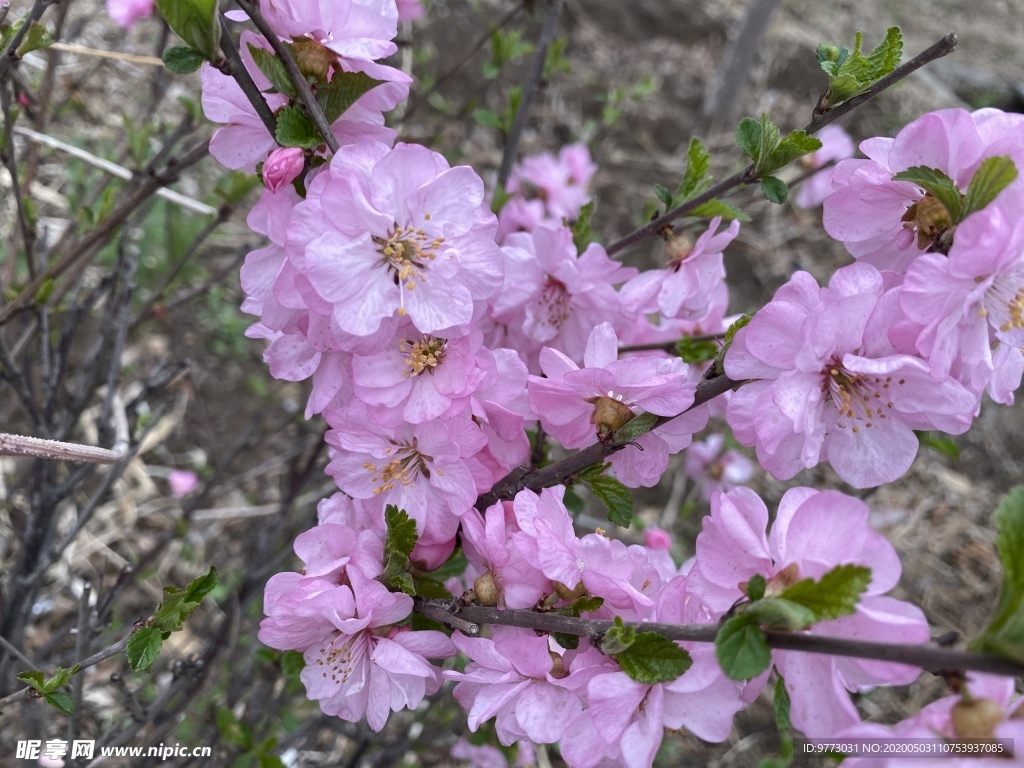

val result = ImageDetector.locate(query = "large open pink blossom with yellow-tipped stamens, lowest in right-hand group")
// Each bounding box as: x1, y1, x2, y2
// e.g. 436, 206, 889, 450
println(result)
725, 264, 976, 487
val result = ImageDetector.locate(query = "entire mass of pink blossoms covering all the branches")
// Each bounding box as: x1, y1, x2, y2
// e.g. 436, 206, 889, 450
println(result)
180, 0, 1024, 768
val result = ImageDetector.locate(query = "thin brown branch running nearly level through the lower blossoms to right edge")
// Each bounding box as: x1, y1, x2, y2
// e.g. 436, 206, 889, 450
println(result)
416, 600, 1024, 677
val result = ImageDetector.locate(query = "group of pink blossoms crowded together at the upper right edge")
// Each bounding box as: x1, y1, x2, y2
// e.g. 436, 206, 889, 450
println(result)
725, 110, 1024, 487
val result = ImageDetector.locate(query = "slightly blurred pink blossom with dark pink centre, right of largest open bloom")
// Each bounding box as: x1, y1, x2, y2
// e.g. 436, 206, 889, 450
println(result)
492, 226, 636, 362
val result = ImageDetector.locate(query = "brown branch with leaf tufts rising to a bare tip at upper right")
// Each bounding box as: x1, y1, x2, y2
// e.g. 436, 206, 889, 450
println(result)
607, 32, 956, 256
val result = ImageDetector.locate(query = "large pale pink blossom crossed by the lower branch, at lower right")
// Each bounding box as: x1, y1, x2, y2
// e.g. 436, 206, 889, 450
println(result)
687, 487, 929, 736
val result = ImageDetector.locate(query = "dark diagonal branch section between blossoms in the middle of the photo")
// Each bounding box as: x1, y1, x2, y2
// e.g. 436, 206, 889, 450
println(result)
475, 376, 739, 512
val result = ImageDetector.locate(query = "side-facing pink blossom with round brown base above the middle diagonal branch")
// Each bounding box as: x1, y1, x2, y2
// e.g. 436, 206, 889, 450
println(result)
527, 323, 708, 487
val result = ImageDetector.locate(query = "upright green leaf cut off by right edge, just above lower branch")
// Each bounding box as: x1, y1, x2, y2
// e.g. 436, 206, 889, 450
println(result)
971, 485, 1024, 663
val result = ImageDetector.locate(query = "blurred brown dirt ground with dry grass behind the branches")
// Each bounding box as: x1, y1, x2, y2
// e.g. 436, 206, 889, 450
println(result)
0, 0, 1024, 766
